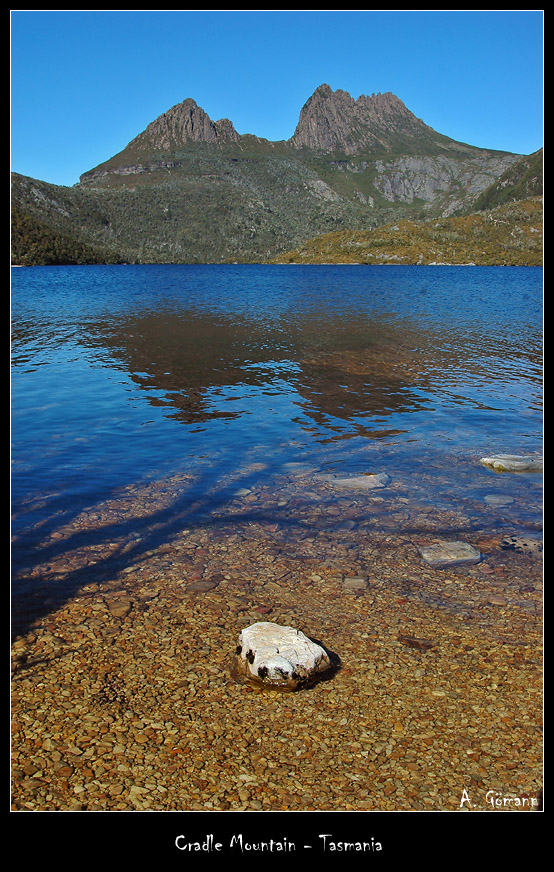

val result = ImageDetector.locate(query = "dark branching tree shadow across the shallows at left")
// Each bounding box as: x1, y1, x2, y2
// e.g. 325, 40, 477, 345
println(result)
11, 459, 292, 639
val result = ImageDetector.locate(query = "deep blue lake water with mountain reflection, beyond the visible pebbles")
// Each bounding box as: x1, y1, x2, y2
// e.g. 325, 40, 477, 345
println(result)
11, 265, 542, 588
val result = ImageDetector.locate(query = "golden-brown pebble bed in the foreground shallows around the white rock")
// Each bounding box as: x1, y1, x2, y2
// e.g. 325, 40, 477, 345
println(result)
11, 470, 543, 811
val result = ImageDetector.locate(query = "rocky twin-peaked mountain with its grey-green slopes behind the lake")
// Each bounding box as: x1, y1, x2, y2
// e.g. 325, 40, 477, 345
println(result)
12, 84, 540, 263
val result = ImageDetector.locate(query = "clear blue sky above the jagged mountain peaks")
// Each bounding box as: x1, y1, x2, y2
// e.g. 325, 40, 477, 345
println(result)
10, 10, 543, 185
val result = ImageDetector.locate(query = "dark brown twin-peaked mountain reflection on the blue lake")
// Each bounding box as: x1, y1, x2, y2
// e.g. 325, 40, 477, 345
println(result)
75, 311, 436, 425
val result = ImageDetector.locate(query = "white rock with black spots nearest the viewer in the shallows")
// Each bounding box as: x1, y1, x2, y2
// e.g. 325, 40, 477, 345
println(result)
231, 621, 331, 690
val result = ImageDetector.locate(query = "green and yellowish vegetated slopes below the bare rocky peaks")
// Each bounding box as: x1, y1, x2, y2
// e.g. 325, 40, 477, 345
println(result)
12, 137, 542, 266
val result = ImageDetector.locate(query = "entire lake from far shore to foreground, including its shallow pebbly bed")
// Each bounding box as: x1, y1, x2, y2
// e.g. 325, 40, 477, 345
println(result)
11, 264, 543, 816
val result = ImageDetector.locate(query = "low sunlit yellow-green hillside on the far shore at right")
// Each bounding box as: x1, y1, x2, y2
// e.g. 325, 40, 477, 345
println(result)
274, 197, 543, 266
